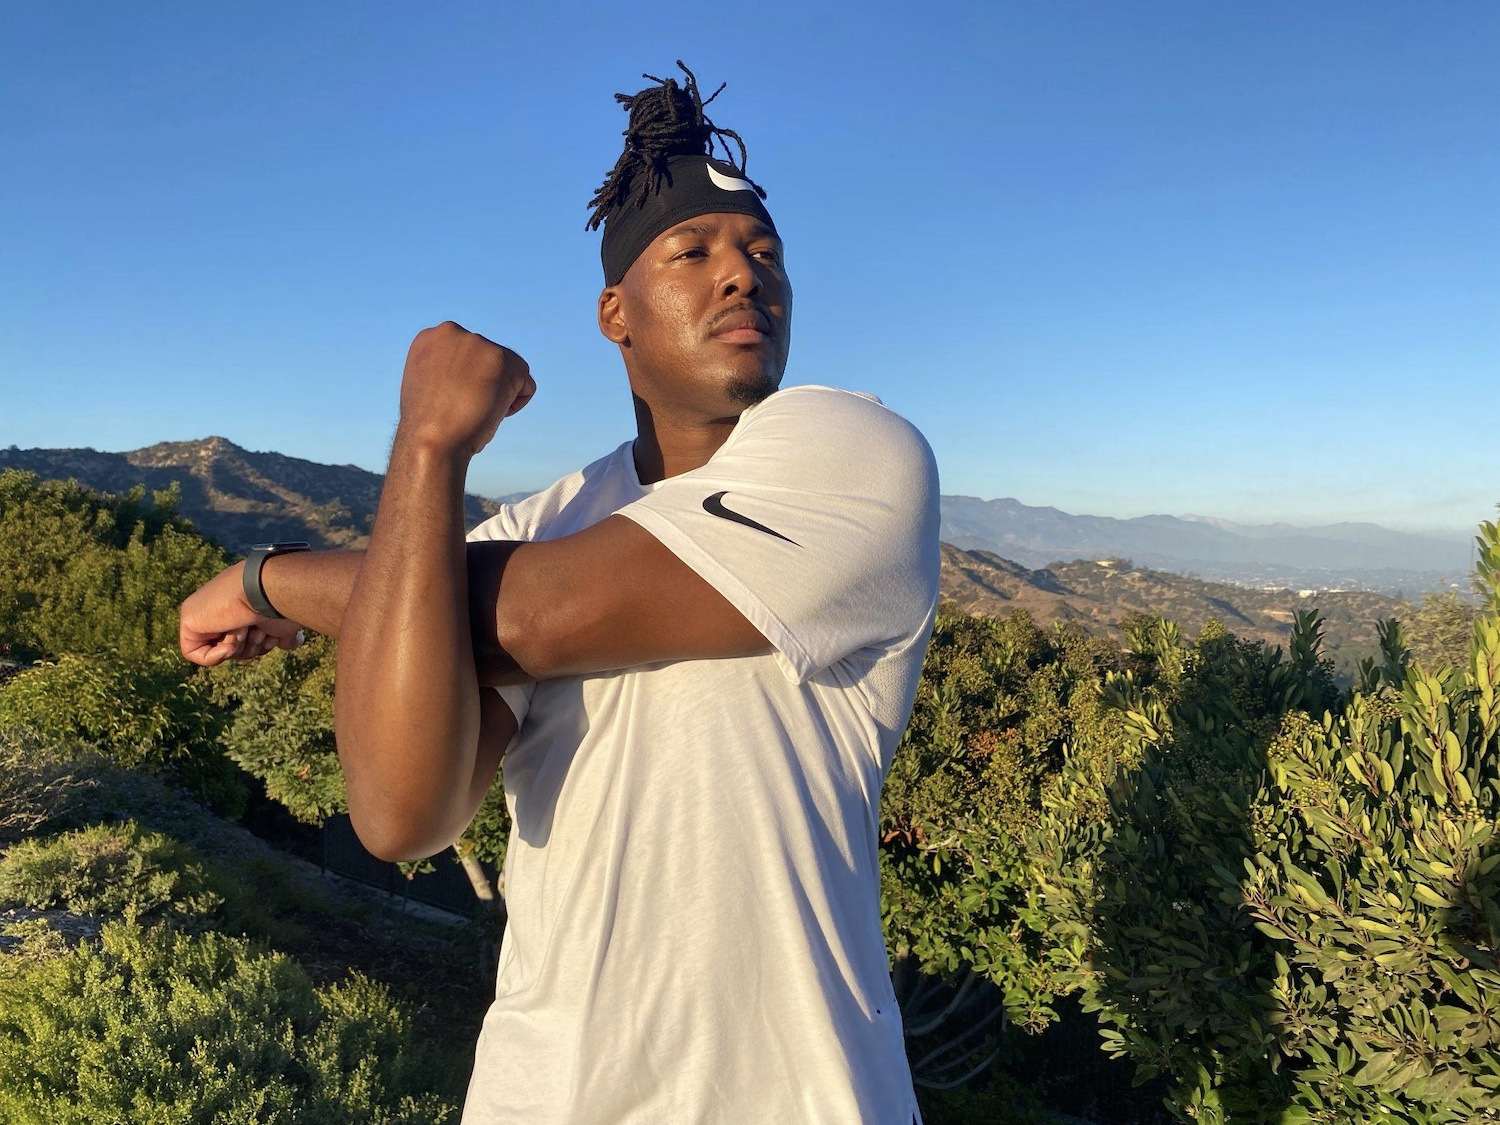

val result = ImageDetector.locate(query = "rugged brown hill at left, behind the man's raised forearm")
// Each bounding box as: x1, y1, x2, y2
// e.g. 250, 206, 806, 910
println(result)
0, 438, 525, 554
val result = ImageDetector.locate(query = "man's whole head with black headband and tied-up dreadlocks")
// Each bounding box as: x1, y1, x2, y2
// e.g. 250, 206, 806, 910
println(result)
590, 63, 792, 417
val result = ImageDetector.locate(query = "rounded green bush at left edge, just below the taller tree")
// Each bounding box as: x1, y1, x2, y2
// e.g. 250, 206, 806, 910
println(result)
0, 650, 246, 816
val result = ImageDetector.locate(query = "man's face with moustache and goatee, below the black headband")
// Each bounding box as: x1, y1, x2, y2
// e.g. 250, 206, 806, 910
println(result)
599, 215, 792, 419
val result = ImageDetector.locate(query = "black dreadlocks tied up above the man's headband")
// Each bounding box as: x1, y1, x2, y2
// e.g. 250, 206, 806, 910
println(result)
587, 59, 765, 231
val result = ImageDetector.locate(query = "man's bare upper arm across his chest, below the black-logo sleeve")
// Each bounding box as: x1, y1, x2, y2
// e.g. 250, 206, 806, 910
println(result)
495, 516, 770, 680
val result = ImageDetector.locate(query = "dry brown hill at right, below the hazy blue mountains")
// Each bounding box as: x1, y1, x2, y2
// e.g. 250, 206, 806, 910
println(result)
942, 543, 1412, 674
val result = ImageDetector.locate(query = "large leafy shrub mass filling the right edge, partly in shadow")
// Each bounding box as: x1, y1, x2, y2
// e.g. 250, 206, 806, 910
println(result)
1032, 525, 1500, 1124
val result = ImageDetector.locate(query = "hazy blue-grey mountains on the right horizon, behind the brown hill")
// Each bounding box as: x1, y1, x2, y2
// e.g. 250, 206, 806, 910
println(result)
941, 497, 1470, 594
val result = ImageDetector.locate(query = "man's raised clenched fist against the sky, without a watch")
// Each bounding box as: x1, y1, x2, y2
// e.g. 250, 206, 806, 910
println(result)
399, 321, 537, 458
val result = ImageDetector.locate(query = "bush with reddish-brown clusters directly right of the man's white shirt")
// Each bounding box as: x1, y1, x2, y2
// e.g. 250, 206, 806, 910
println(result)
881, 611, 1121, 1083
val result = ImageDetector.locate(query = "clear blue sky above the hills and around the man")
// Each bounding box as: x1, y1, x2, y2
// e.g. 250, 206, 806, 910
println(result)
0, 0, 1500, 530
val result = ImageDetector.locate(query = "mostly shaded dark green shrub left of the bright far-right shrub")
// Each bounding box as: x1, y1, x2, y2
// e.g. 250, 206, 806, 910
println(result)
1034, 614, 1335, 1112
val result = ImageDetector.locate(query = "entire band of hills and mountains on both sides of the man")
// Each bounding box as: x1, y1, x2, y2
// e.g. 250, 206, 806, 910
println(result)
0, 437, 1428, 671
